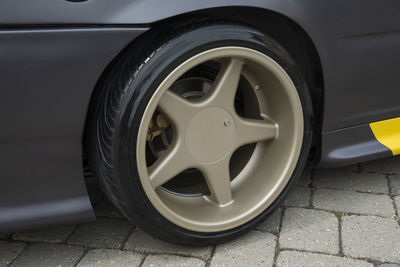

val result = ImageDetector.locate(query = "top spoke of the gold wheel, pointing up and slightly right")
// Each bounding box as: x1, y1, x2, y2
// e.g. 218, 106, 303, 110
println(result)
206, 58, 243, 111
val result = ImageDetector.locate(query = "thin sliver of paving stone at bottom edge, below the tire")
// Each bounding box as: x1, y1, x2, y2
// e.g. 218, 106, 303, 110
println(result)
142, 255, 205, 267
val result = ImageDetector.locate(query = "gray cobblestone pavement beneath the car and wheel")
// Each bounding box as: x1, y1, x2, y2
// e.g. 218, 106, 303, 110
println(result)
0, 157, 400, 267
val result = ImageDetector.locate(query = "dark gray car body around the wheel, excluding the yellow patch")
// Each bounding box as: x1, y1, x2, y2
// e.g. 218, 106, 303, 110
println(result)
0, 0, 400, 232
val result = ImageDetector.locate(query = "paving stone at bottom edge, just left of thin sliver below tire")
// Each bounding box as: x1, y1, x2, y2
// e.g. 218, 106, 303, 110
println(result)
77, 249, 144, 267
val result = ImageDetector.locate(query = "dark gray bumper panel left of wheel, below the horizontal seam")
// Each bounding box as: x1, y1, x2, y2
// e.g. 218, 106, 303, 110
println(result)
0, 28, 144, 231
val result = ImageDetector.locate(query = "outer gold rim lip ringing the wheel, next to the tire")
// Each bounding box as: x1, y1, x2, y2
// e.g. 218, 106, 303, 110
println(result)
136, 46, 304, 232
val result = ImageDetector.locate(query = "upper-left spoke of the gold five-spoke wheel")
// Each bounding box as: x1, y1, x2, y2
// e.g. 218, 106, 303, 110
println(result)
158, 90, 197, 130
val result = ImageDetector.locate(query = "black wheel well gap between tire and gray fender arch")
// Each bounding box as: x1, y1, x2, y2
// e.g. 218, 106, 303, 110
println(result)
83, 7, 324, 180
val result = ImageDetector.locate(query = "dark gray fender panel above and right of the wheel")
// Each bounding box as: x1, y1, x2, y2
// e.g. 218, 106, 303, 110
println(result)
0, 0, 400, 132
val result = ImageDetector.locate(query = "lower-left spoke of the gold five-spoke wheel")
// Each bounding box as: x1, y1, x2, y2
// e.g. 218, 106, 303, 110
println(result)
147, 141, 191, 188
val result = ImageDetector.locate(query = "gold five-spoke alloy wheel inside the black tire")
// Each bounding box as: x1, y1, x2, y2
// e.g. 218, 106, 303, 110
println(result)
136, 47, 303, 232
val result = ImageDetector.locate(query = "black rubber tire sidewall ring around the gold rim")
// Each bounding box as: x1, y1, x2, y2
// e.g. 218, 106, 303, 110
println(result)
113, 23, 312, 245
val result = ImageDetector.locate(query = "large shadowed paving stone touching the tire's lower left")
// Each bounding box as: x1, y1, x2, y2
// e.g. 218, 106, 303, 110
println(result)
67, 218, 134, 248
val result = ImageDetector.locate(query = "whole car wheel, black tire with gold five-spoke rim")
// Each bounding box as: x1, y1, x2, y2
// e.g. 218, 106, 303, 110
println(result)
88, 19, 312, 245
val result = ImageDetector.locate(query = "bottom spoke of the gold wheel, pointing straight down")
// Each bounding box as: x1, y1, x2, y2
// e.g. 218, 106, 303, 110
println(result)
200, 159, 232, 205
